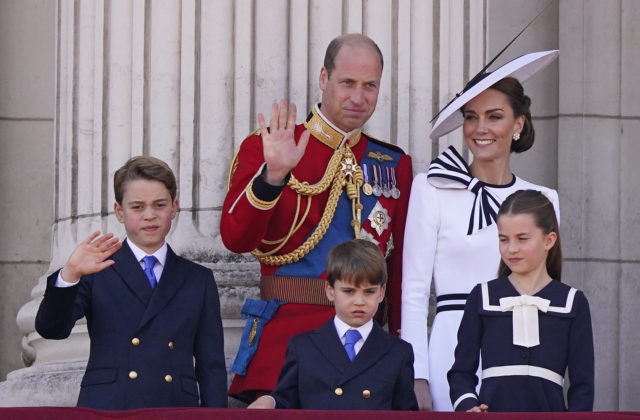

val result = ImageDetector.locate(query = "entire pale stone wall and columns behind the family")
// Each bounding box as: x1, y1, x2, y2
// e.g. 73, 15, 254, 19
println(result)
0, 0, 640, 410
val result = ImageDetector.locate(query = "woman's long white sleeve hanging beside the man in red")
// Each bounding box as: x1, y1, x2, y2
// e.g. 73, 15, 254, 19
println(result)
400, 173, 440, 380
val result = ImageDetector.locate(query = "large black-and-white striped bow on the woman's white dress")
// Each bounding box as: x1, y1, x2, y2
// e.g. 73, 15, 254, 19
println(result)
427, 146, 501, 235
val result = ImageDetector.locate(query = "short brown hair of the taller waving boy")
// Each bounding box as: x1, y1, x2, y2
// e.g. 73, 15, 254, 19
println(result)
113, 156, 178, 205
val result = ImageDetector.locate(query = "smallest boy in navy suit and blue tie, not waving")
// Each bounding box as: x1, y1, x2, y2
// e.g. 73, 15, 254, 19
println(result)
249, 239, 418, 410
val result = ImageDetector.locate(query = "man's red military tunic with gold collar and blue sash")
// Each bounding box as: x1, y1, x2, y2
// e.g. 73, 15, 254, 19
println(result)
220, 108, 413, 400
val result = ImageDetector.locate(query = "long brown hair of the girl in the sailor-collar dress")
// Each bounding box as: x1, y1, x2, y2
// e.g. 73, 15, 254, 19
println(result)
498, 190, 562, 281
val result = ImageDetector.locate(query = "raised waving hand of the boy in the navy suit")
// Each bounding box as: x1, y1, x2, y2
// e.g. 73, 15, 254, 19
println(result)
60, 231, 122, 283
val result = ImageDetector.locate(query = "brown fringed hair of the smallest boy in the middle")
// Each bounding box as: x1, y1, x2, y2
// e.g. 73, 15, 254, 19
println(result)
327, 239, 387, 287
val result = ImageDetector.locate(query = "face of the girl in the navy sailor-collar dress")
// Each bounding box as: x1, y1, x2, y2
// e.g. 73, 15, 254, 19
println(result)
498, 213, 558, 275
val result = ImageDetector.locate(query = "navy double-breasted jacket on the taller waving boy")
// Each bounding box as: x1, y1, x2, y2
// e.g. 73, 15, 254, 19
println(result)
36, 241, 227, 410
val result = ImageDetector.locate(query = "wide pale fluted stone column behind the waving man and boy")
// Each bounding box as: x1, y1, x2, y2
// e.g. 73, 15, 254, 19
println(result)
0, 0, 496, 405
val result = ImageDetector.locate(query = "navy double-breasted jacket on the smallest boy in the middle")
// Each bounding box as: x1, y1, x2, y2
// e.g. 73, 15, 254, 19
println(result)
271, 318, 418, 410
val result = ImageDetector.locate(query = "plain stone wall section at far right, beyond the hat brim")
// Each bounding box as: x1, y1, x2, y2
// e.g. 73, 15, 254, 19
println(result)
558, 0, 640, 410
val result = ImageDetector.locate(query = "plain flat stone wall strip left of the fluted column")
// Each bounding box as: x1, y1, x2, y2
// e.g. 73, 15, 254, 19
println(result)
0, 0, 55, 379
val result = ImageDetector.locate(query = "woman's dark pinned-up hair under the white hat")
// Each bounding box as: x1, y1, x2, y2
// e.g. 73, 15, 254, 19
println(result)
460, 76, 536, 153
